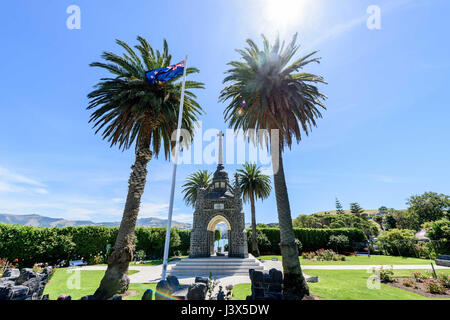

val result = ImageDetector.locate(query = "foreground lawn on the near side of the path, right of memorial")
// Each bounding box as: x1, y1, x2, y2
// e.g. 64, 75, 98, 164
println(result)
233, 270, 450, 300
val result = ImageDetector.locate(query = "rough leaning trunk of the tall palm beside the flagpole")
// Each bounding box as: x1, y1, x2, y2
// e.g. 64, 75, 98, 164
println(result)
94, 147, 152, 300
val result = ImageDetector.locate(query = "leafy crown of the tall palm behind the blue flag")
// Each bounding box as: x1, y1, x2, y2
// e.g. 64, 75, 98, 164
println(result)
87, 36, 204, 158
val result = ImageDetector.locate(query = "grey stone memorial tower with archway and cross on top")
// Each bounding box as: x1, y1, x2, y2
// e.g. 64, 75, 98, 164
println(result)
189, 132, 248, 258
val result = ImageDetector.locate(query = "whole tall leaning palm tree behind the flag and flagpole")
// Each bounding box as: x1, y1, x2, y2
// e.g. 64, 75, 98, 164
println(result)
87, 37, 204, 299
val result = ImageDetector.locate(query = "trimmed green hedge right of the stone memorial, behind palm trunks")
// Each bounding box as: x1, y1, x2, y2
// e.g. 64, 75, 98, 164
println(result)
247, 228, 366, 254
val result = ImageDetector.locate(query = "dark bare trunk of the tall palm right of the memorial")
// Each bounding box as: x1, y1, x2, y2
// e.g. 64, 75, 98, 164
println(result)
271, 138, 309, 300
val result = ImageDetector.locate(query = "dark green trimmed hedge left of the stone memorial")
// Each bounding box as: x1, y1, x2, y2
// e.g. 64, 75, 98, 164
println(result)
0, 223, 190, 267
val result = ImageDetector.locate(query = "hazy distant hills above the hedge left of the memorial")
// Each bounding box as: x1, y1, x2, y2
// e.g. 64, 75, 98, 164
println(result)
0, 213, 191, 229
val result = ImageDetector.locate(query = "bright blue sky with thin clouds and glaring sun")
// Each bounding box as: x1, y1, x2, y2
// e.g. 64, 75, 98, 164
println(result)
0, 0, 450, 223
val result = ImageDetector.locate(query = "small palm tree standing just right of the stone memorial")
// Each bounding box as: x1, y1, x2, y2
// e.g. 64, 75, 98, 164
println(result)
237, 163, 272, 257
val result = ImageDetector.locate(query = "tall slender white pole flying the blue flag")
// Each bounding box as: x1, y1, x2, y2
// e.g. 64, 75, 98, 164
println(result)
161, 55, 187, 280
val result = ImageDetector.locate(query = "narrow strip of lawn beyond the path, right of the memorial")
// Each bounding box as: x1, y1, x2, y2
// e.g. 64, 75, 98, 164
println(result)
258, 255, 430, 266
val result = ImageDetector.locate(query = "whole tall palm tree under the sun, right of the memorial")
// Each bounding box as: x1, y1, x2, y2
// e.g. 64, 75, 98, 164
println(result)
219, 34, 326, 299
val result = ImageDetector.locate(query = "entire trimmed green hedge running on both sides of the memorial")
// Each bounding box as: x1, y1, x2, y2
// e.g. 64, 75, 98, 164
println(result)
0, 223, 365, 267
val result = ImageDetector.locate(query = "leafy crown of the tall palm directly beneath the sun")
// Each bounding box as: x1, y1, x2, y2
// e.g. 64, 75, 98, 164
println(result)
219, 34, 327, 148
